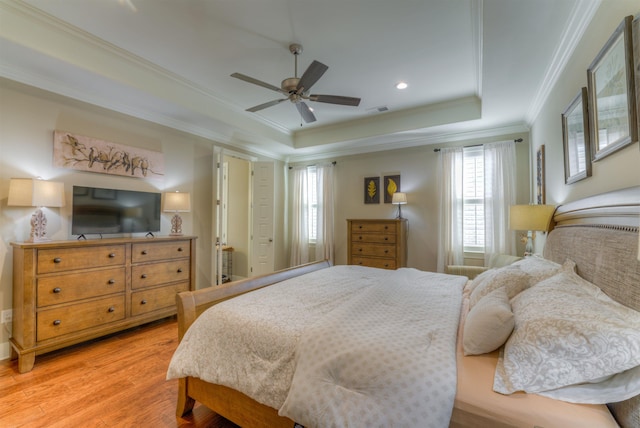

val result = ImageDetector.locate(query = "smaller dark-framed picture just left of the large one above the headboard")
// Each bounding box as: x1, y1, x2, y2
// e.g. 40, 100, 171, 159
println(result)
561, 88, 591, 184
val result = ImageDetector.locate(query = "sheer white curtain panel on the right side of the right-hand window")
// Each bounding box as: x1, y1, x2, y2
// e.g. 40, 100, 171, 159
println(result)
484, 141, 516, 260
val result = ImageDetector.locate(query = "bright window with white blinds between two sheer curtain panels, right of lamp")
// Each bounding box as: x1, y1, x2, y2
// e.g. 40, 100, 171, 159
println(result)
462, 146, 485, 253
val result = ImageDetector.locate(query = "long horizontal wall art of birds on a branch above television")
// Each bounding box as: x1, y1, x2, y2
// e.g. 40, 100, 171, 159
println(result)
53, 131, 164, 178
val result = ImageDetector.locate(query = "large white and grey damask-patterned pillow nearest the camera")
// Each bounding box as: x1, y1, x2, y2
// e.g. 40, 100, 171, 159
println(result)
493, 270, 640, 403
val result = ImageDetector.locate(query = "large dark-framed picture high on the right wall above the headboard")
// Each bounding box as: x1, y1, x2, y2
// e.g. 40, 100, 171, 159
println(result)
587, 16, 638, 161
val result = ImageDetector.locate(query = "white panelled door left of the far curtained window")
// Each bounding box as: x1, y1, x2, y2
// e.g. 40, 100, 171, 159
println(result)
251, 162, 274, 276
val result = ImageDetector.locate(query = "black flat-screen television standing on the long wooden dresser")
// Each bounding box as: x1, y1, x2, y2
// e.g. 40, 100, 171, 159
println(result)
71, 186, 161, 235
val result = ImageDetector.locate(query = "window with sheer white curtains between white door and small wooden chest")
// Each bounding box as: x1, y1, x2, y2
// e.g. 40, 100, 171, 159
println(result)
291, 164, 334, 266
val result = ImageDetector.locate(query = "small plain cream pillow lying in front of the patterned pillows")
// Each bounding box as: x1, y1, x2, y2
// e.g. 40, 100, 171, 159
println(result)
462, 287, 515, 355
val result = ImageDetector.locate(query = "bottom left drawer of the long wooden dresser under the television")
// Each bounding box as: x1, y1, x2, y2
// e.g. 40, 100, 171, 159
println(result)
36, 295, 125, 341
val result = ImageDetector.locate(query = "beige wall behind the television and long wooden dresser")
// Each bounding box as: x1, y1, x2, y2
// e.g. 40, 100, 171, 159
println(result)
0, 79, 286, 359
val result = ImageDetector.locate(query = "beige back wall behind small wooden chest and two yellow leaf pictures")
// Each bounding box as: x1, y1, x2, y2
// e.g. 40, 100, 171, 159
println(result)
290, 134, 530, 271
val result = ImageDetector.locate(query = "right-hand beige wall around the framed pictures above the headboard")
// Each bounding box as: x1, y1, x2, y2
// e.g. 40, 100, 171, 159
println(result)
531, 0, 640, 252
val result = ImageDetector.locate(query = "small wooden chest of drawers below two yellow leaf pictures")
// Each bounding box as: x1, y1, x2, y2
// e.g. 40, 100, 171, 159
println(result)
347, 218, 407, 269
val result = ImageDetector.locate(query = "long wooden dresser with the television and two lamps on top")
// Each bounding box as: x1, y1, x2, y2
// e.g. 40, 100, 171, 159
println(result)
10, 236, 196, 373
